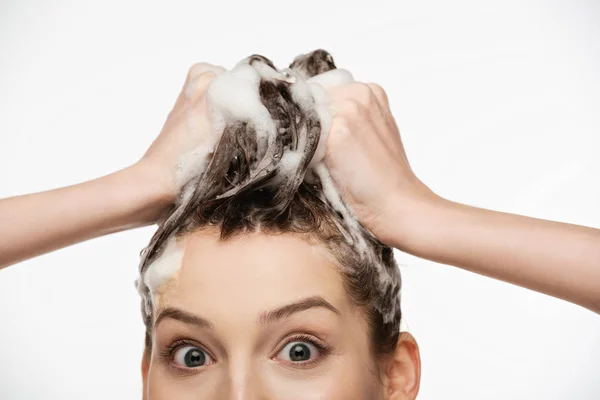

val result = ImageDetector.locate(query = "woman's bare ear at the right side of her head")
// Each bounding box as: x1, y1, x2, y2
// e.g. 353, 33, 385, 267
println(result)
383, 332, 421, 400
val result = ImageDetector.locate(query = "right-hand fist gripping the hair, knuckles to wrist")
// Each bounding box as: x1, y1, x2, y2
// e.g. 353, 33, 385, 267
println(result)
325, 82, 436, 245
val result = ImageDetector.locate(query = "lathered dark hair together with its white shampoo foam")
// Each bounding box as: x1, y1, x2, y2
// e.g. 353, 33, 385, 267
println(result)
137, 50, 400, 340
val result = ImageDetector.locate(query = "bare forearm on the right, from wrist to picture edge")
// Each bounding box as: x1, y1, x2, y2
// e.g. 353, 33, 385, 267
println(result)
393, 193, 600, 313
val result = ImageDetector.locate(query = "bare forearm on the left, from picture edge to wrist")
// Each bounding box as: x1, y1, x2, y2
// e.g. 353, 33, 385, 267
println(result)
0, 164, 170, 268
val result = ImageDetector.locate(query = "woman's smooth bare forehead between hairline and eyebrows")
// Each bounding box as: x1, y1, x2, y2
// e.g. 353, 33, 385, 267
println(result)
159, 230, 350, 317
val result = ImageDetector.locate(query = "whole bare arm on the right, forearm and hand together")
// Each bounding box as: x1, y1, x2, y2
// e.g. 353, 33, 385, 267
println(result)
326, 83, 600, 313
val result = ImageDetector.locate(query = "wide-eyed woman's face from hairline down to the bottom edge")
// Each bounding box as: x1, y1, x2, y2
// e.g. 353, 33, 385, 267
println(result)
146, 229, 410, 400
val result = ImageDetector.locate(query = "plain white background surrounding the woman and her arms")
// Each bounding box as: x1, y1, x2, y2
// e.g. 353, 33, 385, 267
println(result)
0, 0, 600, 400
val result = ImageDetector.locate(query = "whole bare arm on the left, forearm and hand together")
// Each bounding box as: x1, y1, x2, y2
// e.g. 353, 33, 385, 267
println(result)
0, 63, 223, 269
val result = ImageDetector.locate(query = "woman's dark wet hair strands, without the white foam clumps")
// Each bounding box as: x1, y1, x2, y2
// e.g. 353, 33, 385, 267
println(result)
138, 50, 401, 356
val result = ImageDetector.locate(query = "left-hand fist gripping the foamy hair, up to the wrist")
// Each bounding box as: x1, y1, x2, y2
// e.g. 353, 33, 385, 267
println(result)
136, 63, 225, 202
